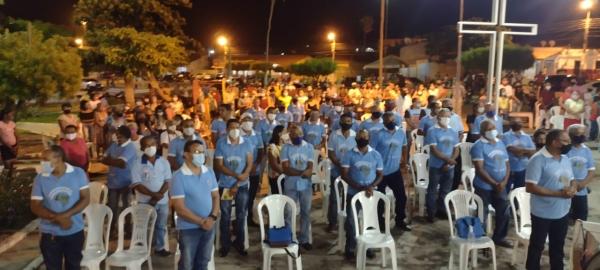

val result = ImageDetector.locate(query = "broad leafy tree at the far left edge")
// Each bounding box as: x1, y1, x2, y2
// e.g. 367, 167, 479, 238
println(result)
0, 27, 83, 104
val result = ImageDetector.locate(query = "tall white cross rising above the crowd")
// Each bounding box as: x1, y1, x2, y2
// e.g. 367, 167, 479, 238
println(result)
458, 0, 538, 112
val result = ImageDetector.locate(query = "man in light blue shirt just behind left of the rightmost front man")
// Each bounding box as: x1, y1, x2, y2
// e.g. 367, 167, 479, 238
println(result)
502, 120, 536, 192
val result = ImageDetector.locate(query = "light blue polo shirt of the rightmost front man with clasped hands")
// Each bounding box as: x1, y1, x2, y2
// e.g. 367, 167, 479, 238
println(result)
525, 147, 574, 219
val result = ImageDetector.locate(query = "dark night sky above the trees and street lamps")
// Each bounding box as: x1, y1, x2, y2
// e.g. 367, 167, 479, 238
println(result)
1, 0, 600, 51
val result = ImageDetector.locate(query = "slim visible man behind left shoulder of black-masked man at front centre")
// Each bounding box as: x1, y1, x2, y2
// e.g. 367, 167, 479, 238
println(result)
327, 114, 356, 232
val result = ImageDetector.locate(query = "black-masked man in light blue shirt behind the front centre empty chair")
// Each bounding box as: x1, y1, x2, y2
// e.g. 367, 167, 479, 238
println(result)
342, 129, 383, 259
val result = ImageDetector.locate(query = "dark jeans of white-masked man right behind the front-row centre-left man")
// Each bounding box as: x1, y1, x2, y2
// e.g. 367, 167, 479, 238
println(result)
219, 185, 250, 250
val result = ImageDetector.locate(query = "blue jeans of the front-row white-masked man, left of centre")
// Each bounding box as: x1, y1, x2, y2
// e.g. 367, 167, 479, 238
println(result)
177, 227, 216, 270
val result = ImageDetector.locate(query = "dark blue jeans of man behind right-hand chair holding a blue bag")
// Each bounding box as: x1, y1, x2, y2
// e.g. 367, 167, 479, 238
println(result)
475, 187, 510, 242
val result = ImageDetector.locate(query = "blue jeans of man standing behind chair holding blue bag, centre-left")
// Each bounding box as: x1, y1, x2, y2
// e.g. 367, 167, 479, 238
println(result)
284, 188, 312, 244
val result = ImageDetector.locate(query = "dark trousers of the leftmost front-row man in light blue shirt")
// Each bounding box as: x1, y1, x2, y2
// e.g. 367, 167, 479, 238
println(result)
40, 230, 84, 270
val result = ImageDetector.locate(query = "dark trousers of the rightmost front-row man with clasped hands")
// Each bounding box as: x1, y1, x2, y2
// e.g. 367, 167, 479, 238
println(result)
525, 215, 569, 270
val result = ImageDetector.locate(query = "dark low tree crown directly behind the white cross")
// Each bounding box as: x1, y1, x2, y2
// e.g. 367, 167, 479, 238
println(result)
461, 45, 535, 71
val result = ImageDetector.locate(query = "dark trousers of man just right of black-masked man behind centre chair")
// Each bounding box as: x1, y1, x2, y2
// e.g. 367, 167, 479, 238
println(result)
377, 170, 406, 228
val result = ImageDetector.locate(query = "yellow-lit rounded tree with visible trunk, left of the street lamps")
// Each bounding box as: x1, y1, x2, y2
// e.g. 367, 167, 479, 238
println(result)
91, 28, 186, 104
